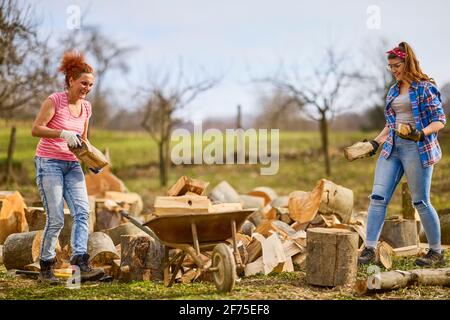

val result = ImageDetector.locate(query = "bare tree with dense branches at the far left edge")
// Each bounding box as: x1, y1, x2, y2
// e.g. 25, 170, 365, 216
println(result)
0, 0, 54, 184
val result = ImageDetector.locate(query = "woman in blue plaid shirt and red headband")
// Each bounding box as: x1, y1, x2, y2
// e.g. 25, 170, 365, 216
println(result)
358, 42, 446, 267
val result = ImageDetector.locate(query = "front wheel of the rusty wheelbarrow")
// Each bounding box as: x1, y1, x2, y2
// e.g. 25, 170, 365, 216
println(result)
212, 243, 236, 292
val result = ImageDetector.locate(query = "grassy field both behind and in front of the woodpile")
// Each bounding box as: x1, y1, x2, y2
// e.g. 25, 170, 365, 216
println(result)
0, 124, 450, 299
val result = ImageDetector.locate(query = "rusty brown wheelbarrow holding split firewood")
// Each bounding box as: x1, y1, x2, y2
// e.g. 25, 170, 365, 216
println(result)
105, 200, 256, 292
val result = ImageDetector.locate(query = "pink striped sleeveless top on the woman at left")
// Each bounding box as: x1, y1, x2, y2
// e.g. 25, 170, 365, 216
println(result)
36, 92, 92, 161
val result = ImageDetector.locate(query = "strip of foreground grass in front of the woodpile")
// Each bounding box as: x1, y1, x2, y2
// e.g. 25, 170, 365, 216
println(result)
0, 253, 450, 300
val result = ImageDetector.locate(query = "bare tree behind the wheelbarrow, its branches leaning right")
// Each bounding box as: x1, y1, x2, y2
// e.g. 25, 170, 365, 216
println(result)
141, 65, 219, 186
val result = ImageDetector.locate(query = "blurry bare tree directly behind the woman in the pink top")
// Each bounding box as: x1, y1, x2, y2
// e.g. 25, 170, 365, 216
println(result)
62, 26, 136, 127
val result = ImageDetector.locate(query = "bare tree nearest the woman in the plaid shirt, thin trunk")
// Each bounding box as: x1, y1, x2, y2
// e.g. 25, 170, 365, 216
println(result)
263, 48, 358, 176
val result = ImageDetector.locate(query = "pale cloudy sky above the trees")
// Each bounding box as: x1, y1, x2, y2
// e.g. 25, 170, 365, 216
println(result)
29, 0, 450, 120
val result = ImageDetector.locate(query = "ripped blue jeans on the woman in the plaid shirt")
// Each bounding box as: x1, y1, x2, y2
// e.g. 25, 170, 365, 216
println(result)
366, 135, 441, 252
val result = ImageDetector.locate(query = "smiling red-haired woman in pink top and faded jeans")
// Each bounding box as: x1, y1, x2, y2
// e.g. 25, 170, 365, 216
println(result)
31, 52, 104, 284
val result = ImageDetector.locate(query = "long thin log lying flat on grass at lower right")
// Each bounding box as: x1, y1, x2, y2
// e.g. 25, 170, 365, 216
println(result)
354, 268, 450, 294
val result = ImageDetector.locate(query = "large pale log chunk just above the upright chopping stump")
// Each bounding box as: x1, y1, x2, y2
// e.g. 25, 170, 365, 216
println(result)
319, 179, 353, 223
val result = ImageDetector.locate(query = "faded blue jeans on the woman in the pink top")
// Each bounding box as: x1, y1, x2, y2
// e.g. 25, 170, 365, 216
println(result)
34, 157, 89, 261
